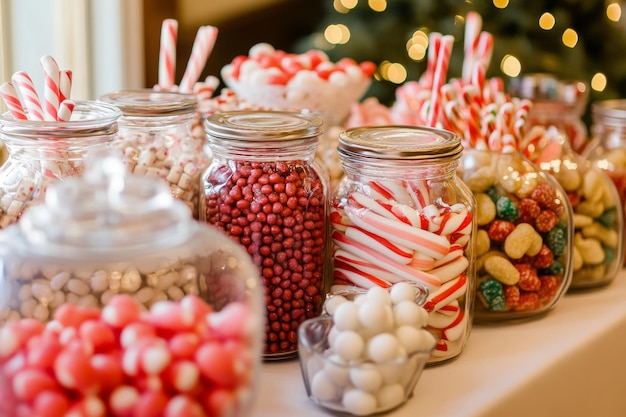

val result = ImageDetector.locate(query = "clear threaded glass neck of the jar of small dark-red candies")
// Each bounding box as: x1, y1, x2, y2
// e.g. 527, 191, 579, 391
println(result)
209, 136, 319, 161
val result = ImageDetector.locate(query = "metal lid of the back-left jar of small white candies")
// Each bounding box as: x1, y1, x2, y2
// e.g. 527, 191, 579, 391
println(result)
100, 89, 198, 117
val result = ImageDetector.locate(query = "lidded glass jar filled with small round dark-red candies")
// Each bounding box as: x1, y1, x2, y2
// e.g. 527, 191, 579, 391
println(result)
200, 111, 329, 360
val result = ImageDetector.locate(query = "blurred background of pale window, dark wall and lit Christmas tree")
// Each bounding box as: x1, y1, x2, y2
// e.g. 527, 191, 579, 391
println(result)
0, 0, 626, 124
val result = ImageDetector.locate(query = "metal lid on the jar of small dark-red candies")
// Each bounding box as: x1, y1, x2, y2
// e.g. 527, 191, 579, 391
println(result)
205, 111, 323, 142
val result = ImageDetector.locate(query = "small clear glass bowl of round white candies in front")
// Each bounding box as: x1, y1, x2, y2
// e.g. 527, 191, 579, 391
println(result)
298, 282, 436, 415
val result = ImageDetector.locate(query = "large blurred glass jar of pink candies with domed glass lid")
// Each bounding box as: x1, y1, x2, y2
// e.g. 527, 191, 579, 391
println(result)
0, 155, 263, 417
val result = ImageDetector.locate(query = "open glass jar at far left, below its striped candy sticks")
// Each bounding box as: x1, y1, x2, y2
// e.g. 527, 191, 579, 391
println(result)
0, 101, 121, 229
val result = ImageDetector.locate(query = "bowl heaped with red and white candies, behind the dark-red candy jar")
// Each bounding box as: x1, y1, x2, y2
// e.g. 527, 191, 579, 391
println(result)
221, 43, 376, 126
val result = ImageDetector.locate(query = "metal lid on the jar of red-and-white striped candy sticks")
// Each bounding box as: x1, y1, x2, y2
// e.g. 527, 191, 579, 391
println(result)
337, 126, 463, 160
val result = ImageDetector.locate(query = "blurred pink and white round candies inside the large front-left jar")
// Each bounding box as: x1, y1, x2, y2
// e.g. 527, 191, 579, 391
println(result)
0, 295, 257, 417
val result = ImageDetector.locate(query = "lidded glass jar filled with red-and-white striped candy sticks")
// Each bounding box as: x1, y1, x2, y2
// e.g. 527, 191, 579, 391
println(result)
330, 126, 476, 364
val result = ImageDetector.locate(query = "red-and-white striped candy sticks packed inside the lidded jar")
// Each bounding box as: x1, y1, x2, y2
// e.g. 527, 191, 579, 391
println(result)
330, 180, 473, 361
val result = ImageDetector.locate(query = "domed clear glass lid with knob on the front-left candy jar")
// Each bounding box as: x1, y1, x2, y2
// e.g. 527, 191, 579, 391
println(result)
19, 153, 193, 259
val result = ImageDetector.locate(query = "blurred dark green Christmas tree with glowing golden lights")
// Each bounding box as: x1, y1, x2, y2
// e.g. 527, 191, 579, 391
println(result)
296, 0, 626, 117
